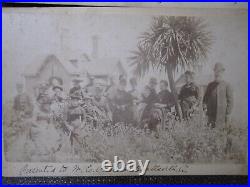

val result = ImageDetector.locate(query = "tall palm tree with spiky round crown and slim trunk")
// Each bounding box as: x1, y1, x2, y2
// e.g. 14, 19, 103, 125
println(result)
130, 16, 212, 118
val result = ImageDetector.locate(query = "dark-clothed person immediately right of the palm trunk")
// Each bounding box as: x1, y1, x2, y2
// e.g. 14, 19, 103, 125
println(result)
179, 71, 200, 120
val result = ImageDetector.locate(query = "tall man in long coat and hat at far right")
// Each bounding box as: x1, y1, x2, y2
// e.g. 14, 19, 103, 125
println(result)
203, 63, 233, 128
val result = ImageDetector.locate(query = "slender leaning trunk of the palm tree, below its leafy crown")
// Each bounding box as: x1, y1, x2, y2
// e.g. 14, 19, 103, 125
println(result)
166, 65, 182, 120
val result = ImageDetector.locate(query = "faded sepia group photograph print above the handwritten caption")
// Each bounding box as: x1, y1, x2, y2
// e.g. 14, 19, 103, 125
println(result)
2, 4, 248, 177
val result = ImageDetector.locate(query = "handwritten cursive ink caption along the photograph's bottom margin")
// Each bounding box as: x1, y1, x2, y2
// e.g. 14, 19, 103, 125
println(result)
18, 163, 189, 176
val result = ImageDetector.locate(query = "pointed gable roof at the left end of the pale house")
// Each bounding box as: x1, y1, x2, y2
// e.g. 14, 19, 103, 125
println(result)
23, 54, 80, 76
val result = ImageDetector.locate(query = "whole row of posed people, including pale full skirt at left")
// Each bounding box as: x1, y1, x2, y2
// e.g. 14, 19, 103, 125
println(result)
8, 63, 233, 159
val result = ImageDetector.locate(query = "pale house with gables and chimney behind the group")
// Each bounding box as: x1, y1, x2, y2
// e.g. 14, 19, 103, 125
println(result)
23, 37, 126, 93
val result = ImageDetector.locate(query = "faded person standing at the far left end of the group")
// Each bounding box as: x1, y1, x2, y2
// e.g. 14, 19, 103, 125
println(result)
13, 83, 33, 117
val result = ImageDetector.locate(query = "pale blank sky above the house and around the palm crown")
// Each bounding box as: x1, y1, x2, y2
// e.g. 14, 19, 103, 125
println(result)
2, 8, 248, 123
